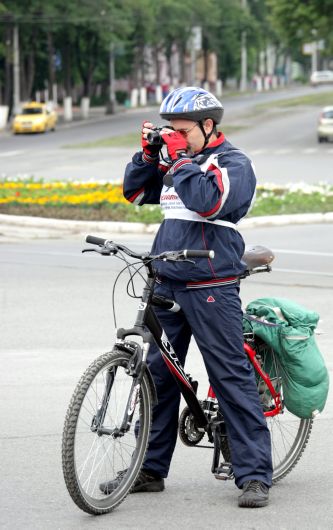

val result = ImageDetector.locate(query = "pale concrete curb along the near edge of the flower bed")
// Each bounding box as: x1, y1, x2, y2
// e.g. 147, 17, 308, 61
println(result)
0, 212, 333, 241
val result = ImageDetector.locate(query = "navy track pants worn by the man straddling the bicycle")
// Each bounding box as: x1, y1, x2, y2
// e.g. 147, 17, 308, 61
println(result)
143, 278, 272, 487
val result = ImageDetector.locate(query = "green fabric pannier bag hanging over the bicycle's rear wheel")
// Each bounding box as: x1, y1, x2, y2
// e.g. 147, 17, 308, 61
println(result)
243, 298, 329, 418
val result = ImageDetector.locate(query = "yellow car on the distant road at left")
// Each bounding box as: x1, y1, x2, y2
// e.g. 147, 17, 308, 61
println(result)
12, 102, 58, 134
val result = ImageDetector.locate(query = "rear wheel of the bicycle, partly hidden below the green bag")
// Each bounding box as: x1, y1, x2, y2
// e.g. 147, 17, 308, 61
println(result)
256, 341, 313, 482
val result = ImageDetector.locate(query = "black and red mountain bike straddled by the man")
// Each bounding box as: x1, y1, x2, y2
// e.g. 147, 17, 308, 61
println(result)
62, 236, 313, 515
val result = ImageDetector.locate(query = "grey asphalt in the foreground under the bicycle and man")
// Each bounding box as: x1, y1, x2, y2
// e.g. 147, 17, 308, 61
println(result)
0, 225, 333, 530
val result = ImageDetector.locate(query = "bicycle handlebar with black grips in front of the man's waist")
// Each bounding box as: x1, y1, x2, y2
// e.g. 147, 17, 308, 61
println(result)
86, 235, 215, 261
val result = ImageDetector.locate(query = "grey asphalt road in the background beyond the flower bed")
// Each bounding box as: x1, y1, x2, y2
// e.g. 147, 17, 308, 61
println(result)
0, 87, 333, 184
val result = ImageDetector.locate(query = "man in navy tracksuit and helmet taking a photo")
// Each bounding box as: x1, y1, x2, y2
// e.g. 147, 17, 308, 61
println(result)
100, 87, 272, 507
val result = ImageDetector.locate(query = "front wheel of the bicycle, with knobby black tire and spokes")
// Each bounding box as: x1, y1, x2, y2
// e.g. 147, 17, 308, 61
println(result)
62, 348, 152, 515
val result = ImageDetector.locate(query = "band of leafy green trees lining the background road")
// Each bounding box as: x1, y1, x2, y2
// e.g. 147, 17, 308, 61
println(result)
4, 0, 326, 108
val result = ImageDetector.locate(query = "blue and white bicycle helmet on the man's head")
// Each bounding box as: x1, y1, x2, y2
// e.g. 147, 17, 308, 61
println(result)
160, 87, 224, 124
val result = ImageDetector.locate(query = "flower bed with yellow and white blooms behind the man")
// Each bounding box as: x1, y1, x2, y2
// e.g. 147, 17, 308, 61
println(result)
0, 178, 333, 223
